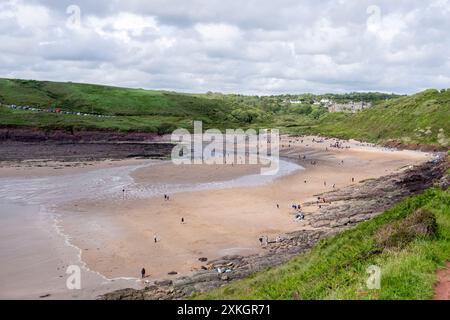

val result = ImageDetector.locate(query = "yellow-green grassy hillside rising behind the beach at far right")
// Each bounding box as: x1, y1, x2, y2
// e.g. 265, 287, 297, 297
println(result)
303, 90, 450, 144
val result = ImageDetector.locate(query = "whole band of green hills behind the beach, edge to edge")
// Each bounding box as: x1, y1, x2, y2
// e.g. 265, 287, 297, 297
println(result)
0, 79, 450, 147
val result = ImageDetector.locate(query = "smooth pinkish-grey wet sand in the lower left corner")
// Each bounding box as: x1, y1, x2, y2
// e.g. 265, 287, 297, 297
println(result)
0, 203, 140, 300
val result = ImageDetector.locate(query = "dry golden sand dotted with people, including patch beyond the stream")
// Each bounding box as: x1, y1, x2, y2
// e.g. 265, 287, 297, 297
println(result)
54, 137, 429, 279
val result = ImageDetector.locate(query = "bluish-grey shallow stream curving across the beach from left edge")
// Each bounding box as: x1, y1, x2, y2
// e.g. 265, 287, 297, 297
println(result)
0, 160, 303, 206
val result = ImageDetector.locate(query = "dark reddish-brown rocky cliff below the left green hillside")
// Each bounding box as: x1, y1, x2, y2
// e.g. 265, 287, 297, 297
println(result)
0, 127, 173, 162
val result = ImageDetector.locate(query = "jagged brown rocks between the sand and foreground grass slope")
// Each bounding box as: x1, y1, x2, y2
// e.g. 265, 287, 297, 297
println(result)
100, 154, 449, 300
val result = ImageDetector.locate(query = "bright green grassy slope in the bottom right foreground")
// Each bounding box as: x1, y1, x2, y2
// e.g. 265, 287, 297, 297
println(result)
196, 189, 450, 299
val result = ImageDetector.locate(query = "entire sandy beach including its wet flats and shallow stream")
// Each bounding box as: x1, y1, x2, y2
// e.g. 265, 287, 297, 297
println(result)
0, 137, 432, 298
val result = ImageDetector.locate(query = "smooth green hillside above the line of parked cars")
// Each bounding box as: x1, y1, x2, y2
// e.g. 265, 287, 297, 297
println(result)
0, 79, 236, 117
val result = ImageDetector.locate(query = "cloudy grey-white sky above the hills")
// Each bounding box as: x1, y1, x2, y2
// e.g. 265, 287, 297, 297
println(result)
0, 0, 450, 94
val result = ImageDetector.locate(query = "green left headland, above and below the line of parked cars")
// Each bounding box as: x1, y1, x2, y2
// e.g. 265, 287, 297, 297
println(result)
0, 79, 237, 131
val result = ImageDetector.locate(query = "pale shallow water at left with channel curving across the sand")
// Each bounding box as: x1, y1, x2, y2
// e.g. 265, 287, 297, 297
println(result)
0, 160, 303, 299
